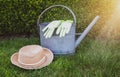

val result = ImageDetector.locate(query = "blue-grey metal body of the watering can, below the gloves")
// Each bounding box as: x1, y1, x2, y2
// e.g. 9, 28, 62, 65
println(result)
39, 23, 75, 54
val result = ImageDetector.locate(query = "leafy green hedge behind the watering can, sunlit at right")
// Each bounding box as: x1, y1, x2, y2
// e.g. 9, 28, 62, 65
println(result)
0, 0, 115, 37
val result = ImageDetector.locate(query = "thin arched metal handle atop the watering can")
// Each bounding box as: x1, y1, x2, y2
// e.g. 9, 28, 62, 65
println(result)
37, 5, 76, 26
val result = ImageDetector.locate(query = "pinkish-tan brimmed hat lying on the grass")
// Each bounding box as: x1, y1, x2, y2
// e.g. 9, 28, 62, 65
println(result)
11, 45, 53, 69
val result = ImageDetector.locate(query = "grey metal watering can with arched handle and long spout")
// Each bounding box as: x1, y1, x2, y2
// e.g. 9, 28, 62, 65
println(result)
37, 5, 99, 54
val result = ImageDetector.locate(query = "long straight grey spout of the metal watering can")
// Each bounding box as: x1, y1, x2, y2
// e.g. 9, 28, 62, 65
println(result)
75, 16, 100, 48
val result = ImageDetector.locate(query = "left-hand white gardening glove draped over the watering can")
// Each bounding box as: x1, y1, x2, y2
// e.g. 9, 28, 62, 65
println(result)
42, 20, 62, 38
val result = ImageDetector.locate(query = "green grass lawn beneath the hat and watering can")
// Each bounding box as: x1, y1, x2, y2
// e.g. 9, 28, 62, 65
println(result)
0, 37, 120, 77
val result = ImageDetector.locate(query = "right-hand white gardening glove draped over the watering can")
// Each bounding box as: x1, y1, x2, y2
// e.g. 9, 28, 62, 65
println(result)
56, 20, 73, 37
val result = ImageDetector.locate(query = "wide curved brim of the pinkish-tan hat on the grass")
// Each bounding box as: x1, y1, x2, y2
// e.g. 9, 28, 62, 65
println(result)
11, 48, 53, 69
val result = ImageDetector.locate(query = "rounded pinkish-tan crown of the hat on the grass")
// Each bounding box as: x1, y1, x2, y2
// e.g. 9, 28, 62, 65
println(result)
18, 45, 44, 64
